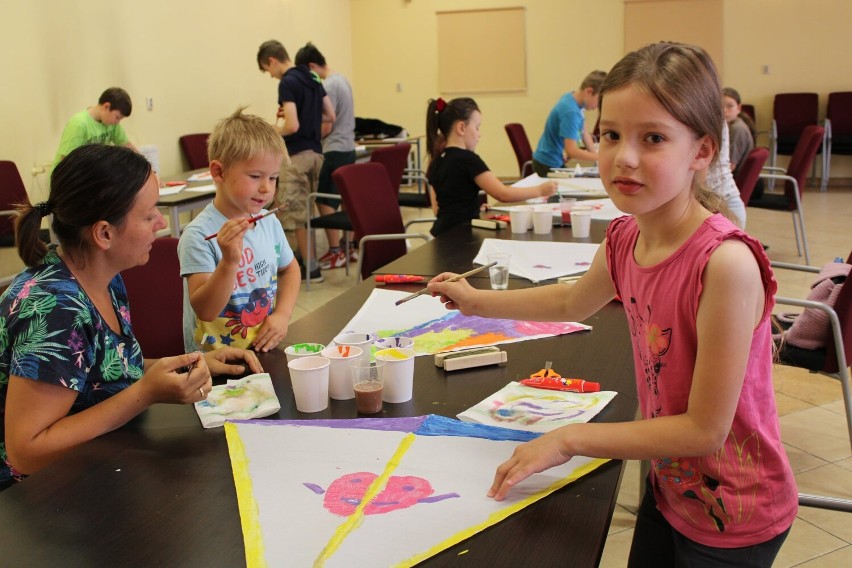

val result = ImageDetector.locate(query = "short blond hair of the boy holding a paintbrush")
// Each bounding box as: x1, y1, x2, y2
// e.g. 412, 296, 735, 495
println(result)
207, 107, 290, 168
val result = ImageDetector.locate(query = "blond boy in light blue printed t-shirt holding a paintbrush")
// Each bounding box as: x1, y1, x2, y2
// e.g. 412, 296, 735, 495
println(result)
178, 109, 300, 351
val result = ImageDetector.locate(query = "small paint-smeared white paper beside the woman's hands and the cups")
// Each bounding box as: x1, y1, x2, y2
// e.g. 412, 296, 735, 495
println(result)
195, 373, 281, 428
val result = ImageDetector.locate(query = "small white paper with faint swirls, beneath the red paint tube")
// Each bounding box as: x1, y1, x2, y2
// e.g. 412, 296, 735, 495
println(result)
458, 381, 618, 433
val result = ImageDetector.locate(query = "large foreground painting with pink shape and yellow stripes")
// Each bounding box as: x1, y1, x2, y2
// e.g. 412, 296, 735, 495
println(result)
225, 415, 607, 568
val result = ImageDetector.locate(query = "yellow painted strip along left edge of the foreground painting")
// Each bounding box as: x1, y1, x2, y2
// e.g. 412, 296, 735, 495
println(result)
225, 422, 267, 568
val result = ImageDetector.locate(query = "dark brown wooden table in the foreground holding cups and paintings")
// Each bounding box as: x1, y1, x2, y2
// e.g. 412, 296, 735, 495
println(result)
0, 250, 637, 567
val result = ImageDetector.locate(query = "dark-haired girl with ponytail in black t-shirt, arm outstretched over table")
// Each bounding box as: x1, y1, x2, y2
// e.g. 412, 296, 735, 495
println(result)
426, 97, 556, 237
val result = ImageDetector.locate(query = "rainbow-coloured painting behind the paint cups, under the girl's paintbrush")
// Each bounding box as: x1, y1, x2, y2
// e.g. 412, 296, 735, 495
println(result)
342, 289, 591, 355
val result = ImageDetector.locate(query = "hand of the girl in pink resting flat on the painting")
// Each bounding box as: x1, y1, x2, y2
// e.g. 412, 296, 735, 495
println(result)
488, 426, 574, 501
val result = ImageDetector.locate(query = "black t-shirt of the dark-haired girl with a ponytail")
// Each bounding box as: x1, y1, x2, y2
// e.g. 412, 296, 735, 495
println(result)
428, 147, 488, 237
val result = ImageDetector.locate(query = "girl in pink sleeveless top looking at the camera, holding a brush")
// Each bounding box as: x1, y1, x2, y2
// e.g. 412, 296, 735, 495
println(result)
429, 43, 798, 566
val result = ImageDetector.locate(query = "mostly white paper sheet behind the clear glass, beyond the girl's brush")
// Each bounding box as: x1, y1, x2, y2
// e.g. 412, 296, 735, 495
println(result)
473, 239, 600, 282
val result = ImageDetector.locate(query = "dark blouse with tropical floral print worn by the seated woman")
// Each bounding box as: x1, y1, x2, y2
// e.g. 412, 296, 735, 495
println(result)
0, 248, 144, 490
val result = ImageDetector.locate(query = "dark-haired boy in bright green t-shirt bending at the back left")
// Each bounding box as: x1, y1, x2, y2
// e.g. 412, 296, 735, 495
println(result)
53, 87, 138, 168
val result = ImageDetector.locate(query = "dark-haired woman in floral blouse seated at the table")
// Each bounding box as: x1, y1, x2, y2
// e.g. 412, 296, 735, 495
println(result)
0, 145, 262, 490
